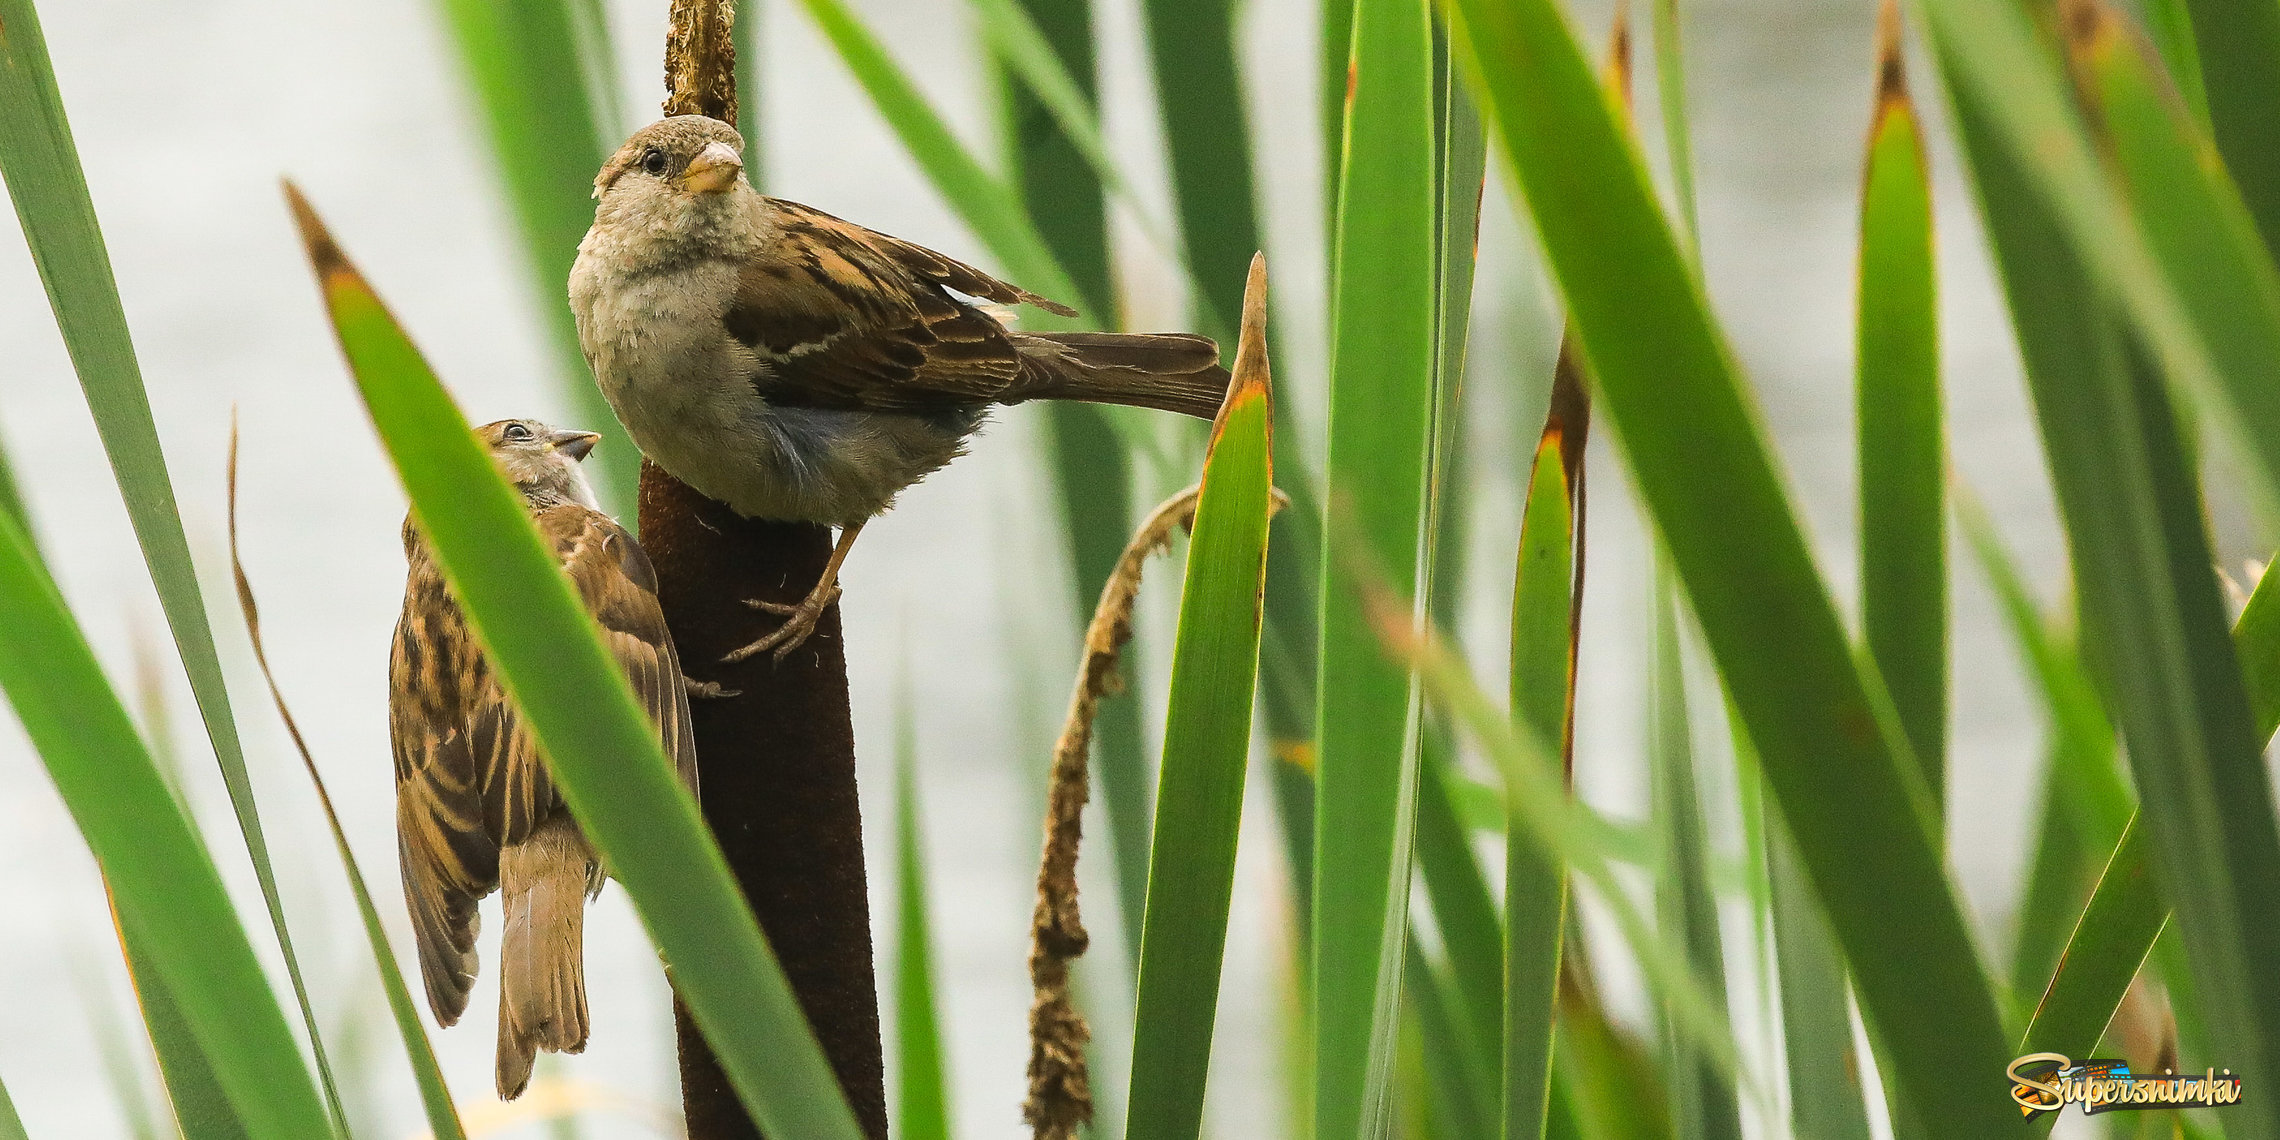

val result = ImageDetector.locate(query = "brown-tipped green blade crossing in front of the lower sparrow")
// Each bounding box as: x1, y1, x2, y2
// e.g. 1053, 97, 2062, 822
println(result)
287, 187, 862, 1140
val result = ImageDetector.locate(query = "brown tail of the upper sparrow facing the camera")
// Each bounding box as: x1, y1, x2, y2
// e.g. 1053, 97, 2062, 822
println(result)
1015, 333, 1227, 420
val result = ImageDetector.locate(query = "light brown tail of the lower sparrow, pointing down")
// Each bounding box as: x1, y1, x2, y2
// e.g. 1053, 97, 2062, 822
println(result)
499, 814, 595, 1101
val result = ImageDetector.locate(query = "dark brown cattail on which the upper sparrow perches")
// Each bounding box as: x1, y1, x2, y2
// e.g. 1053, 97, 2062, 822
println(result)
641, 0, 887, 1140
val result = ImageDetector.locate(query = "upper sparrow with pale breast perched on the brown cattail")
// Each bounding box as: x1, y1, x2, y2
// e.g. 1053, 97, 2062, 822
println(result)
570, 114, 1227, 661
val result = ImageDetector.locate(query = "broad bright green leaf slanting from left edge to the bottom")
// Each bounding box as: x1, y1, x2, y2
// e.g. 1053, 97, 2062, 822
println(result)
0, 515, 333, 1140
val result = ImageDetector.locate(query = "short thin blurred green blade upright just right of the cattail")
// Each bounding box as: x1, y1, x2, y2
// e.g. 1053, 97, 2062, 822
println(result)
894, 675, 951, 1140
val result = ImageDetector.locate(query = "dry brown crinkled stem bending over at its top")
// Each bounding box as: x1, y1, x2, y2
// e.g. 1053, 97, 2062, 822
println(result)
1021, 486, 1202, 1140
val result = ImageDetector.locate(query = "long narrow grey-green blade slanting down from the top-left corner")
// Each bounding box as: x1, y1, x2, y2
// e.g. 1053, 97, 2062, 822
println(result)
0, 0, 347, 1133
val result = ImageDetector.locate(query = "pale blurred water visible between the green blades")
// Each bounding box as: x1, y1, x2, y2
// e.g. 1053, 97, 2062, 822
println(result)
0, 0, 2188, 1140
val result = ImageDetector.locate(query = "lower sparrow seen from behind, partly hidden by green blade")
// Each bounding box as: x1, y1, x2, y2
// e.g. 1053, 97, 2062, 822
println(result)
388, 420, 698, 1099
